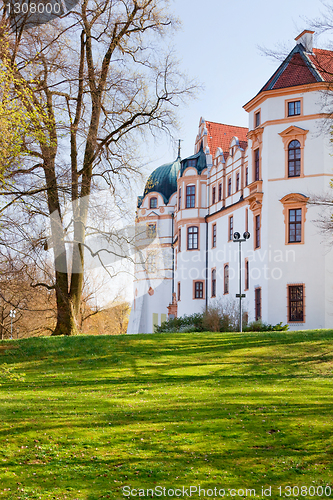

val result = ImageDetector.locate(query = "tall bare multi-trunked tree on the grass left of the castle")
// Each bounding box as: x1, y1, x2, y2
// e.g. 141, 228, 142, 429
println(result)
0, 0, 195, 335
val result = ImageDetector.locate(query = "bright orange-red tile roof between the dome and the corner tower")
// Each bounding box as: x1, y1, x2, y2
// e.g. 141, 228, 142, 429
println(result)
206, 121, 249, 158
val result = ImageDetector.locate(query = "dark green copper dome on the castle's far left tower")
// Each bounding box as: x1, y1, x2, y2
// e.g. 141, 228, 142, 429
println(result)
138, 158, 180, 207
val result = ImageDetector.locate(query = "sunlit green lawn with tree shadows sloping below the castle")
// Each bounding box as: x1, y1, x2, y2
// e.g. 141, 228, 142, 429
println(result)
0, 330, 333, 500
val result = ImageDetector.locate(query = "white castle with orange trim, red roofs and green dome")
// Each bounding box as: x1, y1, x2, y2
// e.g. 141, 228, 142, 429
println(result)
128, 30, 333, 333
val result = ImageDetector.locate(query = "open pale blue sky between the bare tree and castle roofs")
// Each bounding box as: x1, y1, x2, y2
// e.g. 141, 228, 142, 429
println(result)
144, 0, 328, 174
